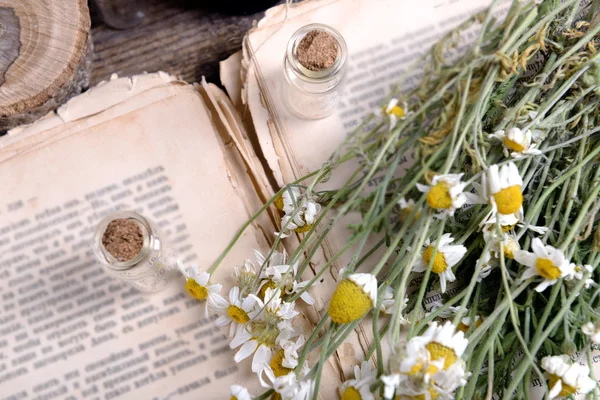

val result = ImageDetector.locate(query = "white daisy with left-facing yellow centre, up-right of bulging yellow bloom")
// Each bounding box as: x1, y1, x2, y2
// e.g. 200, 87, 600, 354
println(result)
414, 233, 467, 293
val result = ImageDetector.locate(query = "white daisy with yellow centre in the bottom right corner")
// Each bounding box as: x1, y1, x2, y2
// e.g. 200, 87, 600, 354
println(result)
542, 354, 596, 399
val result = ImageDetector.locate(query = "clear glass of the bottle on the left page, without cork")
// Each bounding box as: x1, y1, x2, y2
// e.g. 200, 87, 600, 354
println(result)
93, 211, 179, 292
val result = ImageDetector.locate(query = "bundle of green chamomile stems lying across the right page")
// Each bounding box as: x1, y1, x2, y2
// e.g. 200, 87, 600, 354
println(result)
211, 0, 600, 399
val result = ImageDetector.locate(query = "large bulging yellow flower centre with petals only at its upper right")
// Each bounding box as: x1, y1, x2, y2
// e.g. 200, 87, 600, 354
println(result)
329, 279, 373, 324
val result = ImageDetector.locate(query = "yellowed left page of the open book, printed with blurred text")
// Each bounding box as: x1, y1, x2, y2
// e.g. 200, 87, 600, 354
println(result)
0, 76, 273, 400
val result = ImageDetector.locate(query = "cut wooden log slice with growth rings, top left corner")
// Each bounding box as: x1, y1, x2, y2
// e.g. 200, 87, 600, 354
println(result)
0, 0, 92, 130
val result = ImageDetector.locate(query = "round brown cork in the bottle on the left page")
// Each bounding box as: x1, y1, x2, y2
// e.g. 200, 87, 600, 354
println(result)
102, 219, 144, 262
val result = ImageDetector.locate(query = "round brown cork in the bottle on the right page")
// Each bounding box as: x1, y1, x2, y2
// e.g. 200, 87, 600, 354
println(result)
296, 30, 339, 71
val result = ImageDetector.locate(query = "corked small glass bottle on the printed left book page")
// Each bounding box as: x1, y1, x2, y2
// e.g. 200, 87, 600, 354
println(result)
93, 211, 179, 292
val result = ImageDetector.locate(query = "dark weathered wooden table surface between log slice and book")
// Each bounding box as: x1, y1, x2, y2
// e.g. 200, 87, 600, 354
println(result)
91, 0, 263, 85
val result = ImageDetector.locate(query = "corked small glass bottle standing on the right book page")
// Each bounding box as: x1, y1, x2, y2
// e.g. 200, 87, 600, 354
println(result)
283, 24, 348, 119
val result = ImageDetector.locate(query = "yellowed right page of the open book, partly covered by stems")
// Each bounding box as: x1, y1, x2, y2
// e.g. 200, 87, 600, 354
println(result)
243, 0, 510, 378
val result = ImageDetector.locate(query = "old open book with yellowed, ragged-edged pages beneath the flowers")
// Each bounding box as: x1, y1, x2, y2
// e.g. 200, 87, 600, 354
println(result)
0, 0, 580, 400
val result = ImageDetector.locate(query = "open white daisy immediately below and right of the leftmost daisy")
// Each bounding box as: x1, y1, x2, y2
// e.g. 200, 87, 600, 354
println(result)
208, 286, 258, 337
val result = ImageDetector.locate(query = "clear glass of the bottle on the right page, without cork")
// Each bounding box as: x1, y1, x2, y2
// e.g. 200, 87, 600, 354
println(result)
283, 24, 348, 119
